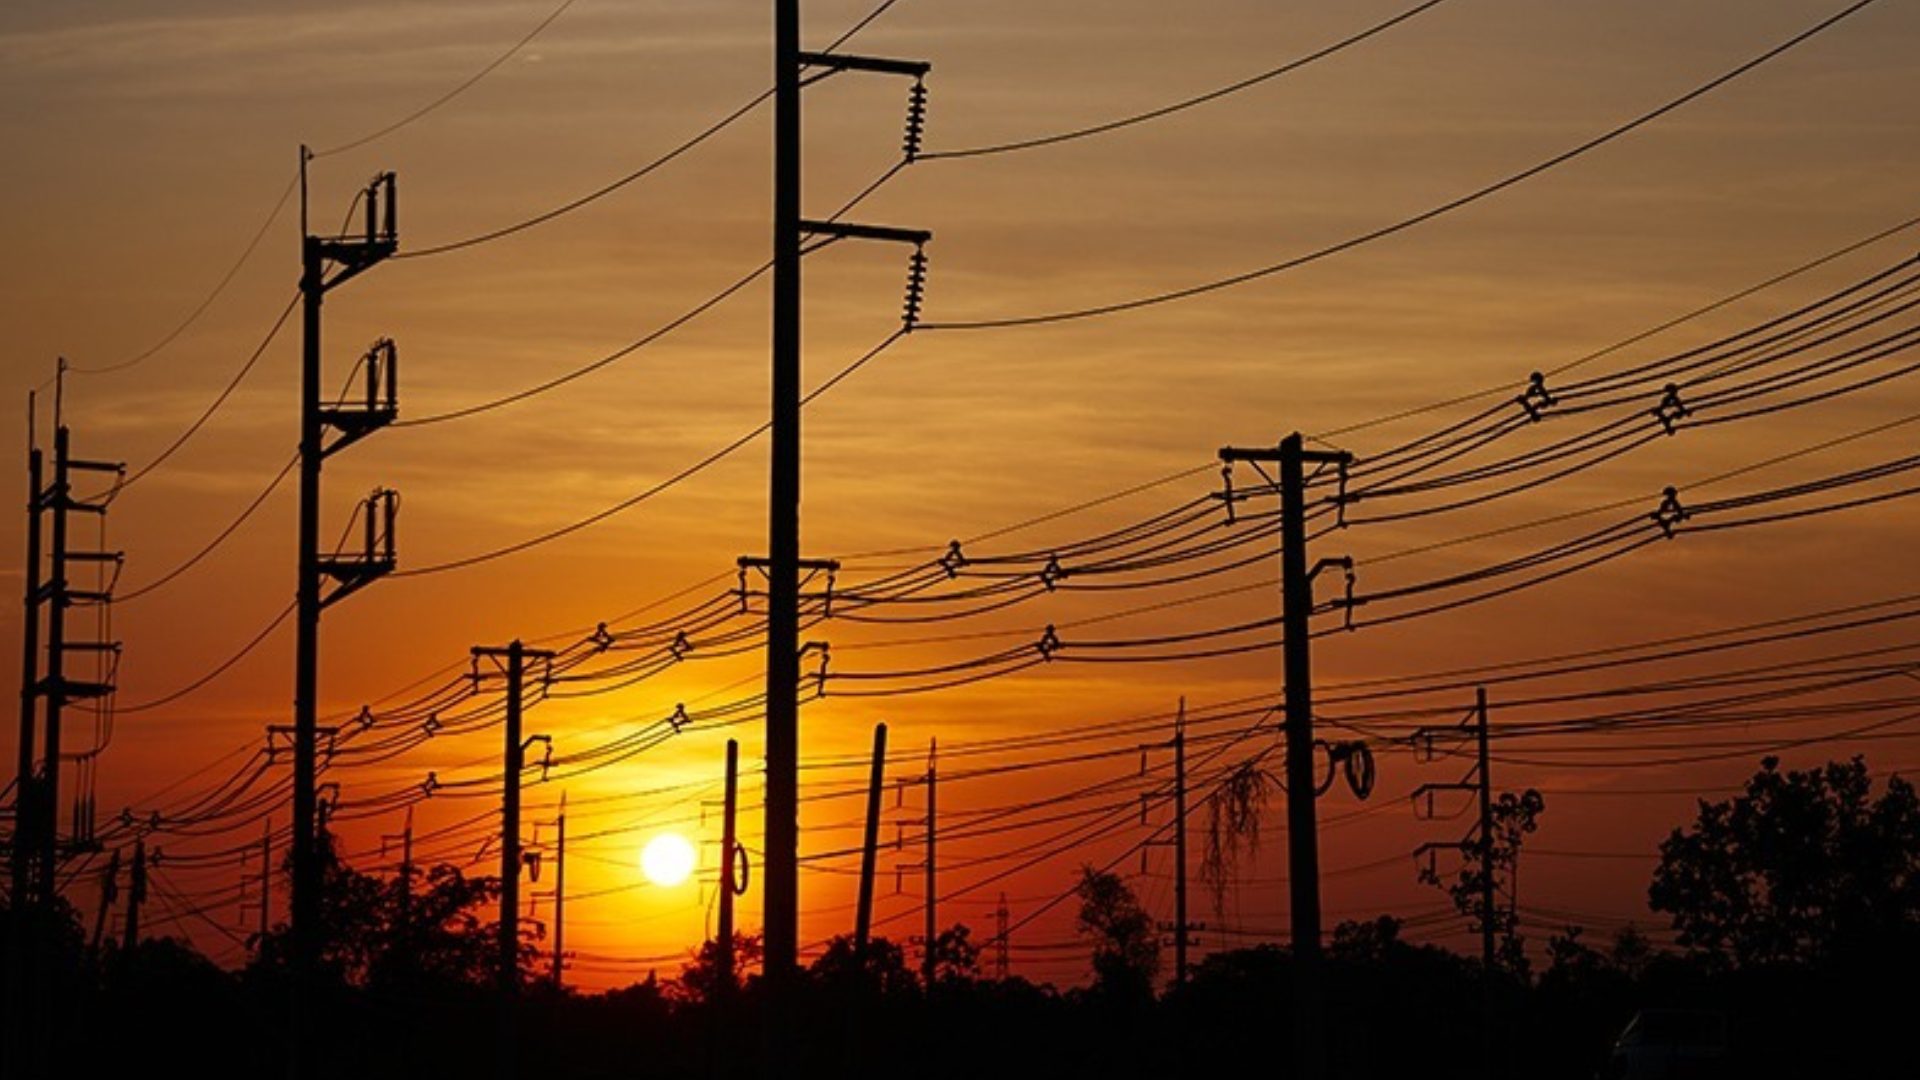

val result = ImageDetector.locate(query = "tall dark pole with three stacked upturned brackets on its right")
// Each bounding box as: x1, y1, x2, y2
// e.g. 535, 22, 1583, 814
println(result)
290, 146, 399, 1076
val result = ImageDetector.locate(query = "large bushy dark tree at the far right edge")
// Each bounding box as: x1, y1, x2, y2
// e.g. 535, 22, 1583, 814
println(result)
1647, 757, 1920, 967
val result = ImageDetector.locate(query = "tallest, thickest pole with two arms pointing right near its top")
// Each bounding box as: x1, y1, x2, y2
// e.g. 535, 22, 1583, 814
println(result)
762, 0, 931, 991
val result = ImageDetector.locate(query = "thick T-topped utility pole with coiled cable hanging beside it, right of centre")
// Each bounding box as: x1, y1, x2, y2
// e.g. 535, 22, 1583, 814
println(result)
1219, 432, 1354, 1080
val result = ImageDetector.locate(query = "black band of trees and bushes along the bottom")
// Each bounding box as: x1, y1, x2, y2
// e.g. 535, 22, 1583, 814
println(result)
0, 761, 1920, 1080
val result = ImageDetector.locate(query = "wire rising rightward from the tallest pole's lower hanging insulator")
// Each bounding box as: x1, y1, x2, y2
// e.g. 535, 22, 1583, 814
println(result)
920, 0, 1876, 331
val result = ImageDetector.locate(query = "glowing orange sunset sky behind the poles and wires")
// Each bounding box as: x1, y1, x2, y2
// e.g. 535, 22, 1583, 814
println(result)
0, 0, 1920, 986
